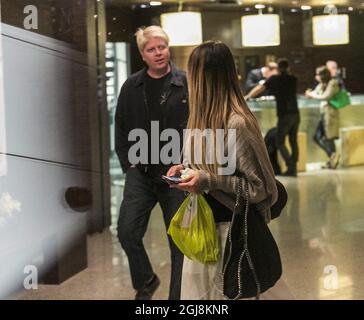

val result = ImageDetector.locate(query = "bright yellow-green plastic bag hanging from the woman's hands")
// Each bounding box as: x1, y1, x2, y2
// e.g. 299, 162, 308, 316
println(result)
168, 193, 220, 263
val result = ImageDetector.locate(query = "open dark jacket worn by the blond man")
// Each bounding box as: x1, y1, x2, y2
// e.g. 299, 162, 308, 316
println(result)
115, 65, 188, 172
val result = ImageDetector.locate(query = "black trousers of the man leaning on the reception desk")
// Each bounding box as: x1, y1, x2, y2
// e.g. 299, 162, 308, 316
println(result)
276, 113, 300, 170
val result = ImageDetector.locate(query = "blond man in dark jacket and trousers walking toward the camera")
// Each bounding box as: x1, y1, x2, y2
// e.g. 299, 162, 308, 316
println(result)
115, 26, 188, 300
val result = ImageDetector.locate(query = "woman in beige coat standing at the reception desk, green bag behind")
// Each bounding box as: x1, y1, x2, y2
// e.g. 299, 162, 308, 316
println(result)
306, 66, 340, 169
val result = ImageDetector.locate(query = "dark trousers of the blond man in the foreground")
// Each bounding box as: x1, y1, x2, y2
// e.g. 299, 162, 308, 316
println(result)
118, 168, 185, 300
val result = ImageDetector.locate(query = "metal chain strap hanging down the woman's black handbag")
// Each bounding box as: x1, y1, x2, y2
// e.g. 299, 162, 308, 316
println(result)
221, 176, 261, 300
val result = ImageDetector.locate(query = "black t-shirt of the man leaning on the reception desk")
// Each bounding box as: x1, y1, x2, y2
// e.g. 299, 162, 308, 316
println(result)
264, 73, 298, 117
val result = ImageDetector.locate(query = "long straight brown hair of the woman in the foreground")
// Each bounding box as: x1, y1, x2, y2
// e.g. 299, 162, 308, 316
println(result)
187, 41, 260, 174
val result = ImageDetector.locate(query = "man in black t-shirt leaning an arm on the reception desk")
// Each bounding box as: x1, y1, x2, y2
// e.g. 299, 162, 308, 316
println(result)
245, 59, 300, 177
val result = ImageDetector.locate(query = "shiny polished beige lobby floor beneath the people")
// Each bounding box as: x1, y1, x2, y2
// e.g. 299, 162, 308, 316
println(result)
15, 167, 364, 299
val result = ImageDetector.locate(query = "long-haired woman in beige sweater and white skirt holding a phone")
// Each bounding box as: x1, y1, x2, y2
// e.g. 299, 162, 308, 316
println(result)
167, 41, 292, 299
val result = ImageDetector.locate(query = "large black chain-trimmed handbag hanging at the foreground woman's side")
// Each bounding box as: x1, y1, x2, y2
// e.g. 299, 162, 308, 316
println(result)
222, 177, 287, 300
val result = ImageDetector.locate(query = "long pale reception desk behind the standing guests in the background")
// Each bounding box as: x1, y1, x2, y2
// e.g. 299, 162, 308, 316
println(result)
248, 95, 364, 165
